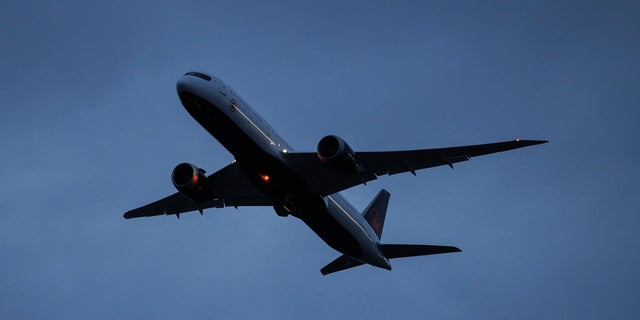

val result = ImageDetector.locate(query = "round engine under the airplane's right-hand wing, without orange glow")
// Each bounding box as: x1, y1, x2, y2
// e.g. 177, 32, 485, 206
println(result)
318, 135, 358, 174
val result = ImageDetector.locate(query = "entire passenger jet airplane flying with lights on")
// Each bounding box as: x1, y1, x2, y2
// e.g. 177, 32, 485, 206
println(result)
124, 71, 547, 275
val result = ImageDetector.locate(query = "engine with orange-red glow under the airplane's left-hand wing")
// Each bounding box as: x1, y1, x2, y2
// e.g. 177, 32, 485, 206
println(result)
171, 162, 213, 201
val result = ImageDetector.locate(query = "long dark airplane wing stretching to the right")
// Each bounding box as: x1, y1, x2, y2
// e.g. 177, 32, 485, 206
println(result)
286, 139, 548, 195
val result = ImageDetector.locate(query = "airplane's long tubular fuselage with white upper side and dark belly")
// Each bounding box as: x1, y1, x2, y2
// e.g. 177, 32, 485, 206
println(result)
177, 72, 391, 269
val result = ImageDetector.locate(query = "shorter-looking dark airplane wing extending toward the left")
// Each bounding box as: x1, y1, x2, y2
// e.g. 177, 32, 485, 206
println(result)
124, 164, 273, 219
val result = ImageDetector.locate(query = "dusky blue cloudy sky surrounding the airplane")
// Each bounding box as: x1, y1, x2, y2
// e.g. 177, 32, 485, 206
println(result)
0, 1, 640, 319
